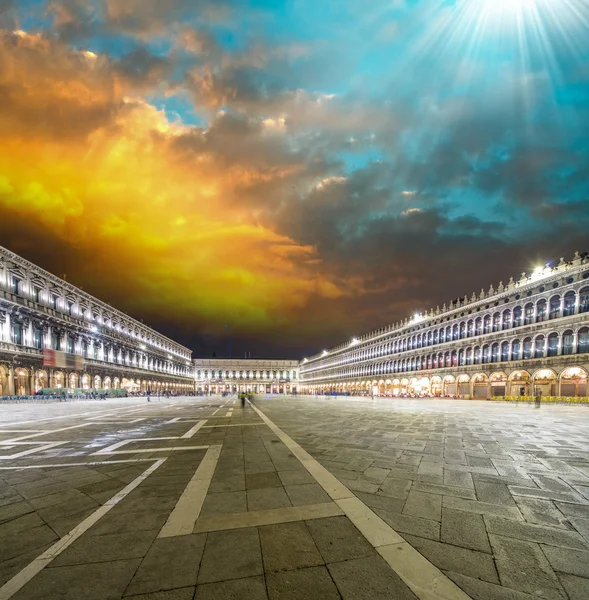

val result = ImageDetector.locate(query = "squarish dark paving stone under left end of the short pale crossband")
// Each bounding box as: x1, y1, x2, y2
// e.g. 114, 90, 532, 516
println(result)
198, 527, 264, 591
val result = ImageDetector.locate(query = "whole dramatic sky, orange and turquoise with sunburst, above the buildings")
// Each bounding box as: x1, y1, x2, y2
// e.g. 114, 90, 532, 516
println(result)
0, 0, 589, 358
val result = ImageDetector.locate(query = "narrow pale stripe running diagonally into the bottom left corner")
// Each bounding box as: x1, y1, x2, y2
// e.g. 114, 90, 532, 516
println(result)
0, 458, 166, 600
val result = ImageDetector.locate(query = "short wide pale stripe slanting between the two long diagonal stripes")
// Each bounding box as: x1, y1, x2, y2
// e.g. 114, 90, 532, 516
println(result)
158, 445, 221, 538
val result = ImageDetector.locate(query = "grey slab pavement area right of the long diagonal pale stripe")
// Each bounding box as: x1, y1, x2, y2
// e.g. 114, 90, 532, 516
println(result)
258, 398, 589, 600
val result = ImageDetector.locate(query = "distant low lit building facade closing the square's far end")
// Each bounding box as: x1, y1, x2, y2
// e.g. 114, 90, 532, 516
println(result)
194, 358, 299, 394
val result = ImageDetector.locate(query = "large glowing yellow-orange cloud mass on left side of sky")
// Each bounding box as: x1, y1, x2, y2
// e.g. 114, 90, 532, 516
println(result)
0, 33, 358, 338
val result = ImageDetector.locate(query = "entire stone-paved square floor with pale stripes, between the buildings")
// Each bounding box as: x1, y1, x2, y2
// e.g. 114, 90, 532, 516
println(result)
0, 397, 589, 600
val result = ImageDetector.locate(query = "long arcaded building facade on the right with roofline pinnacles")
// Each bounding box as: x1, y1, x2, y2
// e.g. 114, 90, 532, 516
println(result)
300, 253, 589, 398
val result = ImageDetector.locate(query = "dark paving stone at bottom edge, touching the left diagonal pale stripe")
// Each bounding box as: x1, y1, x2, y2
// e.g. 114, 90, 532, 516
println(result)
12, 559, 140, 600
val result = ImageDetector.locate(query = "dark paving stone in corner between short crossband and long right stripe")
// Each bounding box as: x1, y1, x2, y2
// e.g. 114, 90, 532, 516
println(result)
307, 517, 376, 563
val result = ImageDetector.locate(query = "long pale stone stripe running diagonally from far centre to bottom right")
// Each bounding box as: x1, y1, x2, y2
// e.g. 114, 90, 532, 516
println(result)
248, 404, 472, 600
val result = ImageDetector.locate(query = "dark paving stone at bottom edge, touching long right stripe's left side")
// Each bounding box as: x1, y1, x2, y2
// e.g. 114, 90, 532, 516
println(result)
327, 556, 417, 600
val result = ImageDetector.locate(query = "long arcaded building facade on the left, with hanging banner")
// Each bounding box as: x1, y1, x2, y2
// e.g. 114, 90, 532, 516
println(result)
0, 247, 194, 396
